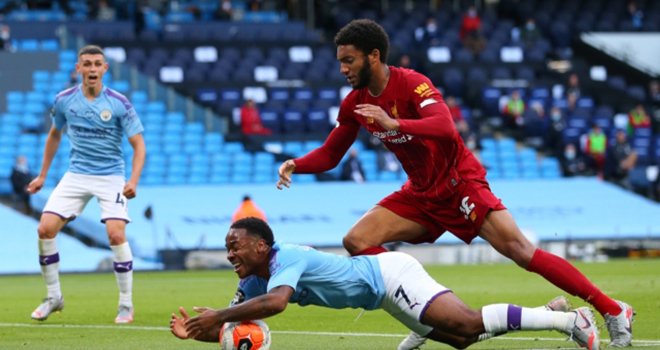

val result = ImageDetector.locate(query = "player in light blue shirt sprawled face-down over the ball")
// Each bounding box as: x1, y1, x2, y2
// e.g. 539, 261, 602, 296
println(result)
170, 217, 600, 350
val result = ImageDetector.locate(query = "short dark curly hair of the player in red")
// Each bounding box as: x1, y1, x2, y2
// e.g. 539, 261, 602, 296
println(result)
335, 19, 390, 63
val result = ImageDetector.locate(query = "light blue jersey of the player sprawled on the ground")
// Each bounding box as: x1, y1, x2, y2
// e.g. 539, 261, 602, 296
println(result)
232, 242, 385, 310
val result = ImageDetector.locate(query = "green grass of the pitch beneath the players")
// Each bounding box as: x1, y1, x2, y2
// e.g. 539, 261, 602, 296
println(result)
0, 259, 660, 350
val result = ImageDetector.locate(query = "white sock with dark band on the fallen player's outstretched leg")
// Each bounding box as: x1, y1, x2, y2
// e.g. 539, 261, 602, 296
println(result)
480, 304, 575, 334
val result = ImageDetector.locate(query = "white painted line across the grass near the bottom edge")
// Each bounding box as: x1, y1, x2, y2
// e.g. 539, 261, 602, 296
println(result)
0, 323, 660, 346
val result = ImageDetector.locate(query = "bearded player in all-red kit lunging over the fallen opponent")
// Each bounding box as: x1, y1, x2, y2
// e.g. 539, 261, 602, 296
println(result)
277, 20, 634, 349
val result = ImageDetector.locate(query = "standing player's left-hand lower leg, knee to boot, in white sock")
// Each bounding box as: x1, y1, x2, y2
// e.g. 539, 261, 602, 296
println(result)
31, 213, 68, 321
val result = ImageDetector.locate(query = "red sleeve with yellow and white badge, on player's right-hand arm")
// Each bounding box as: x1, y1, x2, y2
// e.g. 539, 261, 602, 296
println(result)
399, 74, 456, 138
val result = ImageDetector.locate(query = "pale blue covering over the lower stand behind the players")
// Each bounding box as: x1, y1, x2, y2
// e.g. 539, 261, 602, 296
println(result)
29, 179, 660, 257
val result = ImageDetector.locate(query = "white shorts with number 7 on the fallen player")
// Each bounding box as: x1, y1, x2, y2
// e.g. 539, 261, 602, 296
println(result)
377, 252, 451, 336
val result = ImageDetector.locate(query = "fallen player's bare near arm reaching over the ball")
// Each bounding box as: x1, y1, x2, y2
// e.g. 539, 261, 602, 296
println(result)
184, 286, 293, 339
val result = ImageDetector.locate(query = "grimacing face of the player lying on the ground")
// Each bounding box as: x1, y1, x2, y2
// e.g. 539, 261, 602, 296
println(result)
225, 228, 268, 278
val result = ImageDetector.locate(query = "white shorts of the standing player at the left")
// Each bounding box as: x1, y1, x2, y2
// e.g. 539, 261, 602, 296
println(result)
43, 172, 131, 223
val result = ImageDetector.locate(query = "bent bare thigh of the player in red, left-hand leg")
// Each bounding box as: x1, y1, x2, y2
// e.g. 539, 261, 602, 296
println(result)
343, 205, 428, 255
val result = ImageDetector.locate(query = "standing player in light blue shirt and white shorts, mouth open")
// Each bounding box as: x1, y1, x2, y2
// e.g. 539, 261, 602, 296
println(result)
28, 46, 146, 323
